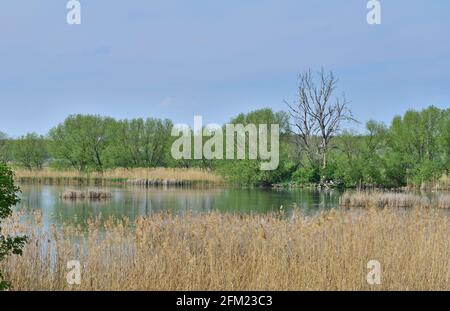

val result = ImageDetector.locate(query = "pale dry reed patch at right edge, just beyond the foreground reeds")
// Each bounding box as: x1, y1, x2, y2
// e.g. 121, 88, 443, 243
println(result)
339, 191, 450, 209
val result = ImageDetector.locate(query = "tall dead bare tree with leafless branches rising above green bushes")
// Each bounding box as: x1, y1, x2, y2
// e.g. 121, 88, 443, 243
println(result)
285, 69, 356, 168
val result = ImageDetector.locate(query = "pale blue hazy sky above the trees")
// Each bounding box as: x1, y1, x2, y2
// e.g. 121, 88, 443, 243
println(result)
0, 0, 450, 137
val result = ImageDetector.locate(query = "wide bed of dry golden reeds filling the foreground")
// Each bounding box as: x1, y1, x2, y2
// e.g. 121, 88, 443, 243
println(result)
0, 208, 450, 290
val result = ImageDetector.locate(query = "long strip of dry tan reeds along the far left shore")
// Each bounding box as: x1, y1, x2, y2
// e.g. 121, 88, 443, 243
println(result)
14, 168, 221, 184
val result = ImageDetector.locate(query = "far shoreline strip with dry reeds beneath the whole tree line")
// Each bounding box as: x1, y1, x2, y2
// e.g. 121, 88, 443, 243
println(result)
14, 168, 450, 192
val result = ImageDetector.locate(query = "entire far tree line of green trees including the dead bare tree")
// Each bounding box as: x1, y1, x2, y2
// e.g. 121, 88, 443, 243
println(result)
0, 70, 450, 187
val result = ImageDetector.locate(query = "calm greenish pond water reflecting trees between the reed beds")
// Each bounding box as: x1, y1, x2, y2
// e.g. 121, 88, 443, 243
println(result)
20, 185, 339, 224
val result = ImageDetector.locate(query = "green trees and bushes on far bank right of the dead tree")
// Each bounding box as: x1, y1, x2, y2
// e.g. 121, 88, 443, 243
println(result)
293, 107, 450, 187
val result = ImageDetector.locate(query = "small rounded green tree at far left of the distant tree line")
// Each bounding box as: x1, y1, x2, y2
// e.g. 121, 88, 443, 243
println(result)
10, 133, 48, 171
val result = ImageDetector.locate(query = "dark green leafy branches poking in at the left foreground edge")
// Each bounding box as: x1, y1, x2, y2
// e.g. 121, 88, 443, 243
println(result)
0, 162, 27, 290
